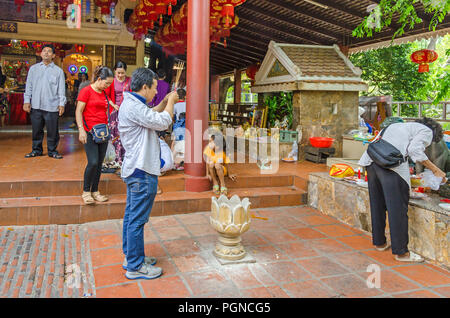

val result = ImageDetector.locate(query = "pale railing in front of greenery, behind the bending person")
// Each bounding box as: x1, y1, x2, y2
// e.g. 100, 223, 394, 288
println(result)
390, 101, 450, 122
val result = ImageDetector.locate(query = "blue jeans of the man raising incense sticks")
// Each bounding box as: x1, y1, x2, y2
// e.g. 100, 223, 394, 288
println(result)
122, 173, 158, 272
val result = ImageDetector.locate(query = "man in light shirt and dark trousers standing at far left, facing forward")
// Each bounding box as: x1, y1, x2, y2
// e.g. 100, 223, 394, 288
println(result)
23, 44, 66, 159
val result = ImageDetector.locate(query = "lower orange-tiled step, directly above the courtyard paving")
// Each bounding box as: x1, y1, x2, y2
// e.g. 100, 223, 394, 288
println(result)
0, 186, 307, 226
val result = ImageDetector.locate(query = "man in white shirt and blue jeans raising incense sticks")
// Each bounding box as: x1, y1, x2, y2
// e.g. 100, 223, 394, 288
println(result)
118, 68, 178, 279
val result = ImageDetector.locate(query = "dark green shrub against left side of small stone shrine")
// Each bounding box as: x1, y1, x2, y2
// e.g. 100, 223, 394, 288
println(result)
264, 92, 293, 127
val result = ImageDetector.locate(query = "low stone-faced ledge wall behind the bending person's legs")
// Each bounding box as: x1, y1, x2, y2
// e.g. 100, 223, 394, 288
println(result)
308, 172, 450, 268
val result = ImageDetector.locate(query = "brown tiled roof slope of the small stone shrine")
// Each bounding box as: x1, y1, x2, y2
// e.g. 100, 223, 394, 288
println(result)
281, 46, 357, 77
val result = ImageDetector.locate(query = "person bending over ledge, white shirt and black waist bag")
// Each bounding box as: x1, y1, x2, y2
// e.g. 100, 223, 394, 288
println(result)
359, 118, 445, 262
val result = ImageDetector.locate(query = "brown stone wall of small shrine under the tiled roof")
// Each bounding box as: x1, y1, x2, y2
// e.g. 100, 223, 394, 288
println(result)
292, 91, 359, 159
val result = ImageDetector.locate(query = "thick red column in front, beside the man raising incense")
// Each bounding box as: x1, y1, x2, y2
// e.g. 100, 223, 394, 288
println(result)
184, 0, 211, 192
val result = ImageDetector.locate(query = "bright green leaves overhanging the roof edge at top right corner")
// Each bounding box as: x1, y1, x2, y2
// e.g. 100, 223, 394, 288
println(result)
352, 0, 450, 39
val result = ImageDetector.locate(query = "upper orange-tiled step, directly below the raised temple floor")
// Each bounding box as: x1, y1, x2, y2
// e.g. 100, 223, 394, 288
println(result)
0, 173, 307, 198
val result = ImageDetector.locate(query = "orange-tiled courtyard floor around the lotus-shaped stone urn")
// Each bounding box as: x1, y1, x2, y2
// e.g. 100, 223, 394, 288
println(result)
0, 207, 450, 298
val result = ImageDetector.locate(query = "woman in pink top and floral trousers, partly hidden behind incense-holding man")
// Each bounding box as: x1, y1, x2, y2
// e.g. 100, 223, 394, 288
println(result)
109, 61, 131, 166
